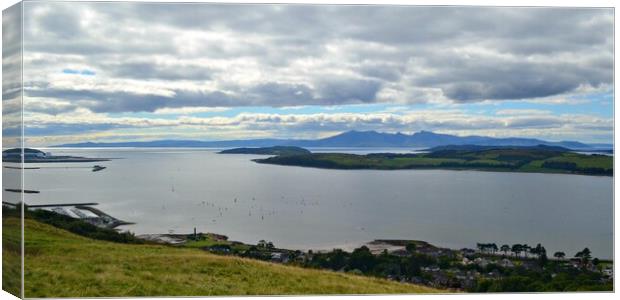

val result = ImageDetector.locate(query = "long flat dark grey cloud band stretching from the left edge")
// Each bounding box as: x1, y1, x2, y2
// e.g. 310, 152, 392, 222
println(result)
26, 80, 379, 114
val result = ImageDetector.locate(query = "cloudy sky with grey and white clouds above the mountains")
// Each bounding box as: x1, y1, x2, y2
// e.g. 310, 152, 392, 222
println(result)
5, 2, 613, 146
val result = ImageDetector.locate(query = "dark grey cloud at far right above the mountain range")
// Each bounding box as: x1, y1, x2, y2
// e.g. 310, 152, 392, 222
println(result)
412, 51, 613, 101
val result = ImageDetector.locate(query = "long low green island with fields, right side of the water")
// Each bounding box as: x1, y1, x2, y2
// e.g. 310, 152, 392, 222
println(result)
246, 145, 613, 176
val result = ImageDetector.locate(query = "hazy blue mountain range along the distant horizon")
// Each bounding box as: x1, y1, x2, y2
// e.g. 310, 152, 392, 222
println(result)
52, 131, 613, 150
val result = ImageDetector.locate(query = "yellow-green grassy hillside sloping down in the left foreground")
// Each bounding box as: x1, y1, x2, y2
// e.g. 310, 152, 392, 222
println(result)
3, 218, 437, 297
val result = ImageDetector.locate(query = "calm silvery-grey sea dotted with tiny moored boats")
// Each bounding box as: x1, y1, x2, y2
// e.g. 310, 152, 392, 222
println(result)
4, 149, 613, 258
